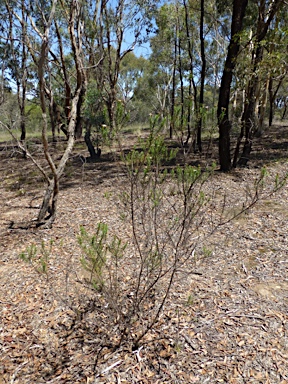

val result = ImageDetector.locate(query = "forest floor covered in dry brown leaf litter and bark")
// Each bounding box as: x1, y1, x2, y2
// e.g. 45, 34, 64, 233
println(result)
0, 126, 288, 384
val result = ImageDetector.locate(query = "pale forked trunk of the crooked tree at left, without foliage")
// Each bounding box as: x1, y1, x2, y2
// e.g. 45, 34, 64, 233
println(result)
26, 0, 86, 226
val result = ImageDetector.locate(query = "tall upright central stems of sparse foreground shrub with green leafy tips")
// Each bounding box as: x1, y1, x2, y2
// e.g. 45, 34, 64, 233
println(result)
113, 116, 214, 345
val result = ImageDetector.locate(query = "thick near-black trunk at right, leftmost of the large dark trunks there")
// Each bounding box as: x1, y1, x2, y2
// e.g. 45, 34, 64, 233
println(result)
217, 0, 248, 172
